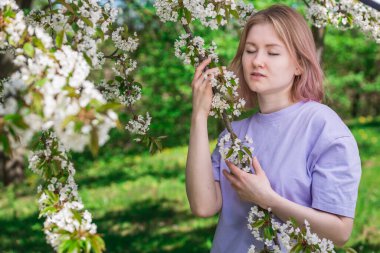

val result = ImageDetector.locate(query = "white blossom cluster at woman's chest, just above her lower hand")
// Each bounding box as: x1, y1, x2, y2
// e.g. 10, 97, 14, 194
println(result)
218, 133, 254, 173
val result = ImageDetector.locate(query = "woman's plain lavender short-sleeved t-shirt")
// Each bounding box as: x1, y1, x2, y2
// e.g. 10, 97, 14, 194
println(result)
211, 101, 361, 253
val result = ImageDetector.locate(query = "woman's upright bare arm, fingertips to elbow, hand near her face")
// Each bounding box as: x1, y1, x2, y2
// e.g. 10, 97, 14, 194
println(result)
186, 59, 222, 217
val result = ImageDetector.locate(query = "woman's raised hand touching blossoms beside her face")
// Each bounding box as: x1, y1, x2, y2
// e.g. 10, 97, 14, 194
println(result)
191, 58, 224, 118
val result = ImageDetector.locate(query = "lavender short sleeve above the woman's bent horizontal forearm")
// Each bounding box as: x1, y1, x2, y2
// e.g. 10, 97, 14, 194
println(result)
311, 136, 361, 218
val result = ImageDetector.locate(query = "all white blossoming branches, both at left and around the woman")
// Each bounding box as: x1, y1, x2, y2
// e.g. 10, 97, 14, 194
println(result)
0, 0, 380, 252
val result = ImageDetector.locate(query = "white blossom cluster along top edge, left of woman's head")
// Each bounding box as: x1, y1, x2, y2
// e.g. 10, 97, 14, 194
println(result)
154, 0, 254, 29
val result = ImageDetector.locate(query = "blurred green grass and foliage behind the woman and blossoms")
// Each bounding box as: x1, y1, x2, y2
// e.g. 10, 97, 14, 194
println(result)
0, 0, 380, 253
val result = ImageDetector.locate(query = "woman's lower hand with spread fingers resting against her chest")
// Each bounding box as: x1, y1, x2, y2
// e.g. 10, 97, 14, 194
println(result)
223, 157, 276, 209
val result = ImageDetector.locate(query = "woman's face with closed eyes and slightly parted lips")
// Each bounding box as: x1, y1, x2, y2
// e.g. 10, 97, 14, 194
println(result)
242, 23, 299, 95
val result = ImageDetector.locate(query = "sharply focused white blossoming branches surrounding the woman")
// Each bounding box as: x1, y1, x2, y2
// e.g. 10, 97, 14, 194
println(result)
155, 0, 380, 253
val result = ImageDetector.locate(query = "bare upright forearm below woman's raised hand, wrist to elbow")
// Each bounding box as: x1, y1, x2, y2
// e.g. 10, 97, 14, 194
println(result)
186, 113, 221, 217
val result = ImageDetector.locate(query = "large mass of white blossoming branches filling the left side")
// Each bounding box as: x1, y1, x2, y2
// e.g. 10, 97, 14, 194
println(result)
0, 0, 160, 252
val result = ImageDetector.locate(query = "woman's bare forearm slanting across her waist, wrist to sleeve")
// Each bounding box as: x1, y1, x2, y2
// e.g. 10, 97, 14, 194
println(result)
269, 193, 352, 246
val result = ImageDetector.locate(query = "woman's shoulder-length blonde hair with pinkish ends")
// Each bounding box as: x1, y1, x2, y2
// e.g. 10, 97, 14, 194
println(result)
230, 5, 324, 108
